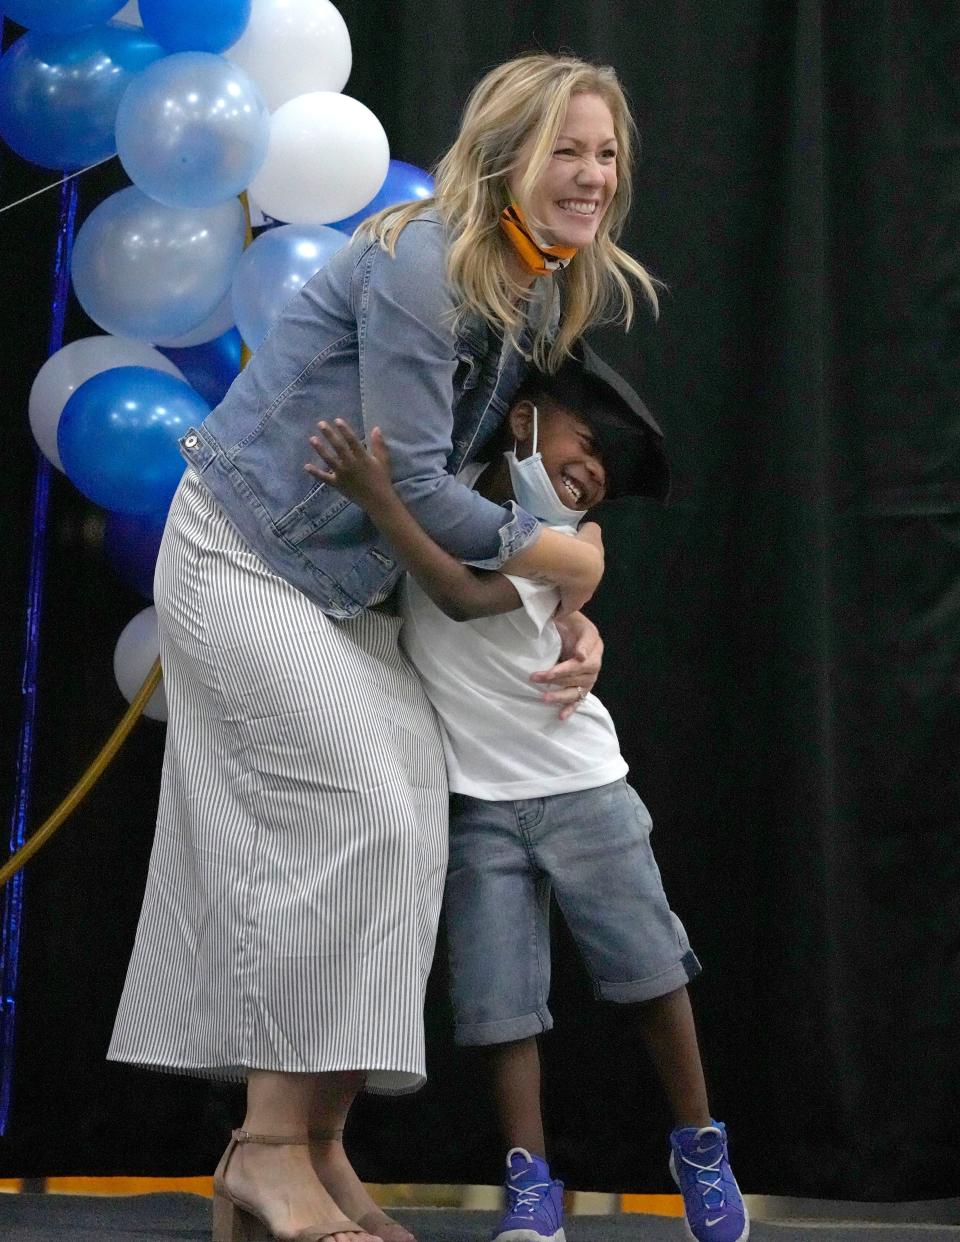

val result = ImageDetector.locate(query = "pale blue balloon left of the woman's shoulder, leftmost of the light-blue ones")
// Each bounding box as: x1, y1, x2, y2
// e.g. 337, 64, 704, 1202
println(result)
72, 185, 246, 340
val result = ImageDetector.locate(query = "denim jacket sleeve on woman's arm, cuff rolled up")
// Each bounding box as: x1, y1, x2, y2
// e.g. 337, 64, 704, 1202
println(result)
354, 221, 539, 569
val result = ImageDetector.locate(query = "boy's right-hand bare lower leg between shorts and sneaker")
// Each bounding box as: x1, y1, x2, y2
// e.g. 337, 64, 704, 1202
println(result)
637, 987, 712, 1126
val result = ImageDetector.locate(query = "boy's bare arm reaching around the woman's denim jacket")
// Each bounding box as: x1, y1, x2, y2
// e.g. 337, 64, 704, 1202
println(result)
304, 419, 520, 621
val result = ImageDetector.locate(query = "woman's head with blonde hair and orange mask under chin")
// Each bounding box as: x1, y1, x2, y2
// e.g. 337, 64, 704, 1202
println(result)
369, 53, 657, 371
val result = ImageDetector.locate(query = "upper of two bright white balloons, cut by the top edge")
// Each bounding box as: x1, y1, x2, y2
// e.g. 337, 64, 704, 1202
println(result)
224, 0, 353, 112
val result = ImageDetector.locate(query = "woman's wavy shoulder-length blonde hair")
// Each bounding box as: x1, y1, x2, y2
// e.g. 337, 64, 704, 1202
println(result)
363, 53, 657, 371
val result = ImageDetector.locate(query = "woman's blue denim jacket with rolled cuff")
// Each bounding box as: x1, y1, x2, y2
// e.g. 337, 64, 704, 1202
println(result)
180, 214, 559, 617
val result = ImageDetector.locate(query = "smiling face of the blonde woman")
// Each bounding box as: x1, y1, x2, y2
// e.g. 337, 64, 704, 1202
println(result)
508, 94, 617, 247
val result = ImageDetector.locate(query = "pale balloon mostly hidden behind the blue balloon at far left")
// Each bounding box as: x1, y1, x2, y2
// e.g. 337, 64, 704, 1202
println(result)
29, 337, 184, 471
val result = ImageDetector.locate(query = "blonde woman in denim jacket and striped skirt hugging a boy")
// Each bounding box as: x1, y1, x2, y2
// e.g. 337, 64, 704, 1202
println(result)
109, 55, 656, 1242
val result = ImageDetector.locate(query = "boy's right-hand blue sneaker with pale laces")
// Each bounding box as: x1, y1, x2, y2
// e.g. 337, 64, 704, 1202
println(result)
669, 1122, 750, 1242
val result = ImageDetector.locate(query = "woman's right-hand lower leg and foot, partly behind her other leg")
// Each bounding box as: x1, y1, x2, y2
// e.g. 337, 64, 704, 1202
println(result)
309, 1073, 416, 1242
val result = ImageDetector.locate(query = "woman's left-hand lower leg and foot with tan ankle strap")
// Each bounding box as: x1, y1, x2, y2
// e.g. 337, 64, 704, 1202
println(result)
225, 1069, 374, 1242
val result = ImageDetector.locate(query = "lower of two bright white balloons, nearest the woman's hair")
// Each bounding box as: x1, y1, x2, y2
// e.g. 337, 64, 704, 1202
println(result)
250, 91, 390, 225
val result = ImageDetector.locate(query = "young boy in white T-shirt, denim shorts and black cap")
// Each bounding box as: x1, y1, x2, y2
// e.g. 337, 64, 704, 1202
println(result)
307, 350, 749, 1242
